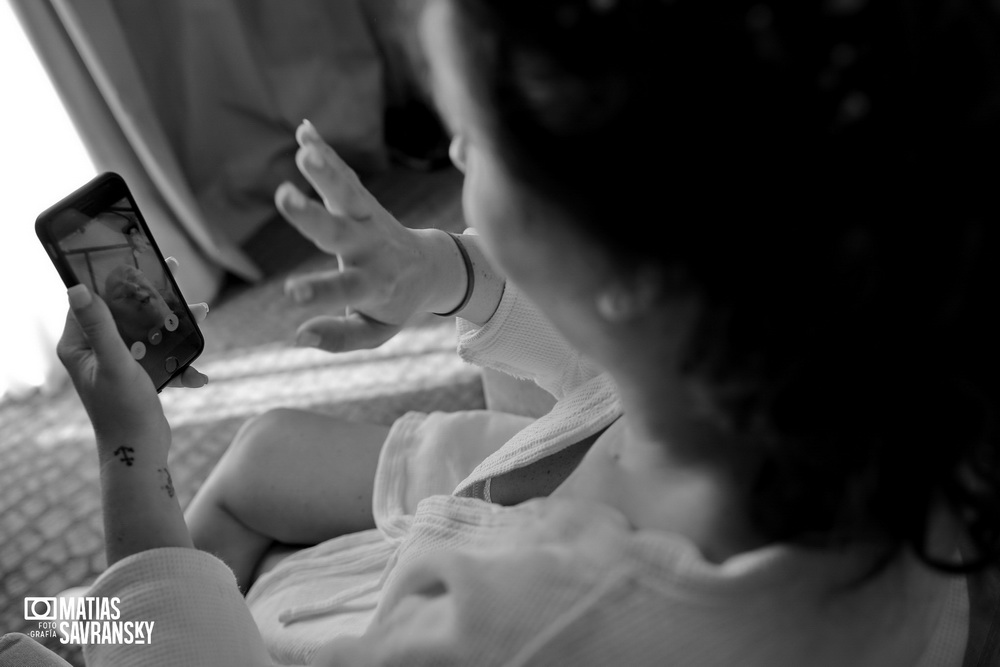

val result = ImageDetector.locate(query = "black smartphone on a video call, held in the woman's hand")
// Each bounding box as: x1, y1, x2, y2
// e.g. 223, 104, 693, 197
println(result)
35, 172, 205, 391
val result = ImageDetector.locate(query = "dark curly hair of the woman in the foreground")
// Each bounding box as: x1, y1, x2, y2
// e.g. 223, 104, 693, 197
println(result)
451, 0, 1000, 571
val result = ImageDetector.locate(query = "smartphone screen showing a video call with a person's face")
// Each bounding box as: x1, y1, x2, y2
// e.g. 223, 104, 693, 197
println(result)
51, 197, 196, 382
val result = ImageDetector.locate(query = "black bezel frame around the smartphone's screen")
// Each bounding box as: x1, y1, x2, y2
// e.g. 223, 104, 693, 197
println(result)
35, 171, 205, 392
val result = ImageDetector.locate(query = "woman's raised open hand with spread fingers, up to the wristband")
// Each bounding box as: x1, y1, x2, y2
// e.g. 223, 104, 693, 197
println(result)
275, 121, 465, 352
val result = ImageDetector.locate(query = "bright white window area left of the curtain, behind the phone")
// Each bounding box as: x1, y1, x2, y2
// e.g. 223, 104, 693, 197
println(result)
0, 1, 96, 400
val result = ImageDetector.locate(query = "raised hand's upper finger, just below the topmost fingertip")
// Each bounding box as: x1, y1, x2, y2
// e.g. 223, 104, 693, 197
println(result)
295, 133, 372, 220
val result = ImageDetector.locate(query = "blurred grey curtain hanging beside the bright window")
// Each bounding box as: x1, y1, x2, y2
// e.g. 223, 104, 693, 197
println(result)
10, 0, 387, 300
